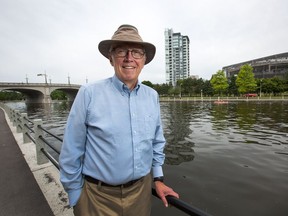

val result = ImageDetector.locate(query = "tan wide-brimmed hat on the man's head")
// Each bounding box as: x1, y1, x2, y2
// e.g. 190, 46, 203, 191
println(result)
98, 25, 156, 64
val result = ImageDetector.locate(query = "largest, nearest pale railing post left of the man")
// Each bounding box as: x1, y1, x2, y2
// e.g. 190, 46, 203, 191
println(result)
33, 119, 49, 165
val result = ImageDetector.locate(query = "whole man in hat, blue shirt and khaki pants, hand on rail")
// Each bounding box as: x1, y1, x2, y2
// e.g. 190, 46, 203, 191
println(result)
59, 25, 179, 216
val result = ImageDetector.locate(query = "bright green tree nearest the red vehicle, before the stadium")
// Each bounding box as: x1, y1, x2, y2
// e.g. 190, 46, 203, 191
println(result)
236, 64, 257, 94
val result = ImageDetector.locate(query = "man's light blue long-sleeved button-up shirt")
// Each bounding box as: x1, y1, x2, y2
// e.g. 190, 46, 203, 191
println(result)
59, 75, 165, 206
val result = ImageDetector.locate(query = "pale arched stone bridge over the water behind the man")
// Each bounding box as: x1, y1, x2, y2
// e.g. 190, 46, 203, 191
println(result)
0, 82, 80, 103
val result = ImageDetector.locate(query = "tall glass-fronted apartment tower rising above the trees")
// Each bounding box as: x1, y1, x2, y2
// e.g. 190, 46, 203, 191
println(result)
165, 29, 190, 86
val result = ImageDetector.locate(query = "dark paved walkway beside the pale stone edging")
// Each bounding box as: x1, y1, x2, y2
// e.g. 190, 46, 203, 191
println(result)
0, 109, 54, 216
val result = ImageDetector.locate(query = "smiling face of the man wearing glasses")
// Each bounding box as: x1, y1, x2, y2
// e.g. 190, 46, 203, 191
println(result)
110, 44, 146, 88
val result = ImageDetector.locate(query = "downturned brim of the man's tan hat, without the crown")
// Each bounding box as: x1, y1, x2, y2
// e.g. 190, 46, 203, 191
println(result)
98, 40, 156, 64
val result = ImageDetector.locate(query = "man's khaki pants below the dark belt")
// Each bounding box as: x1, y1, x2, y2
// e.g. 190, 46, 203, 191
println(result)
74, 174, 152, 216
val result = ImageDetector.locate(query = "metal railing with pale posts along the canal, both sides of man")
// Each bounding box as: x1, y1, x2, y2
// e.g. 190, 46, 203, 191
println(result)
0, 103, 209, 216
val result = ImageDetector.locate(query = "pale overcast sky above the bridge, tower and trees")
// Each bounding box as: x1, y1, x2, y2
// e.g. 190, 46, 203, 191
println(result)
0, 0, 288, 85
